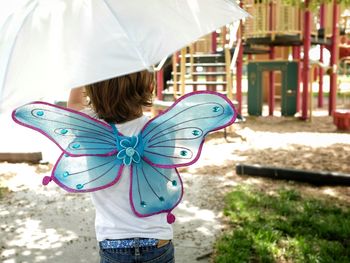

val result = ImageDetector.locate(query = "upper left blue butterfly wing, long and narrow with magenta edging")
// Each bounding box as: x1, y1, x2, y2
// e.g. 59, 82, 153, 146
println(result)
12, 102, 116, 156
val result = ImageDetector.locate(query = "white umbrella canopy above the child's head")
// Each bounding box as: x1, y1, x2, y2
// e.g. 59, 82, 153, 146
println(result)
0, 0, 247, 111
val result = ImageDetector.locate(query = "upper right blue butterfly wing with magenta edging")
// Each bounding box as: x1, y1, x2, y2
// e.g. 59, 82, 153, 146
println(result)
142, 91, 237, 168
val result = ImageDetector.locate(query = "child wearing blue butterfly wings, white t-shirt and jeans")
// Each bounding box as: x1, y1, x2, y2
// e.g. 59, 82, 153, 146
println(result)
12, 67, 237, 262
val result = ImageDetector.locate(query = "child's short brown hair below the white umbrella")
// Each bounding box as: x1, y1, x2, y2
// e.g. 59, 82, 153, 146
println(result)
85, 70, 153, 123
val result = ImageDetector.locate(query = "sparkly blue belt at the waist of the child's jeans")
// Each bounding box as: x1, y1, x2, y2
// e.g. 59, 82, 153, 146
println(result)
99, 238, 158, 249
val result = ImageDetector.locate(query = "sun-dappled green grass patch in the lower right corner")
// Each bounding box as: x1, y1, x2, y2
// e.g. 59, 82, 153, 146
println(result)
214, 187, 350, 263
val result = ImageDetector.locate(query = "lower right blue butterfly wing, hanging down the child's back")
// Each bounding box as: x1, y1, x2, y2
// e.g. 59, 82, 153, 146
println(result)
130, 160, 183, 223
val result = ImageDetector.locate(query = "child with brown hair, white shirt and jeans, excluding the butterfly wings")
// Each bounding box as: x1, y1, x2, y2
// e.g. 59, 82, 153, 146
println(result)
68, 71, 174, 263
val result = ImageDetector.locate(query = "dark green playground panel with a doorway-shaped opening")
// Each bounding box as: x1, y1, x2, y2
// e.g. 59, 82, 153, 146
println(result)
248, 61, 298, 116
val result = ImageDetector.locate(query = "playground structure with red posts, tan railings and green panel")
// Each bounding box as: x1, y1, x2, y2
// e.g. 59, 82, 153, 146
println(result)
157, 0, 350, 130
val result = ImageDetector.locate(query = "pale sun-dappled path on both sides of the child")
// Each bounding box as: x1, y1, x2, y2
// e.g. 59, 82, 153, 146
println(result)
0, 164, 227, 263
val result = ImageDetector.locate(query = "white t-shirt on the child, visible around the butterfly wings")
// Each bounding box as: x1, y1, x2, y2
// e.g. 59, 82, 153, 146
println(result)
83, 110, 173, 241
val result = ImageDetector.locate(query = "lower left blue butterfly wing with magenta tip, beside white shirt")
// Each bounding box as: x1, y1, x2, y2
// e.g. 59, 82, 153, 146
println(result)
51, 154, 124, 192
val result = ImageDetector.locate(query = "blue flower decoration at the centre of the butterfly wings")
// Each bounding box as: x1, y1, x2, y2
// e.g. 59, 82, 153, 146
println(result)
117, 136, 141, 165
